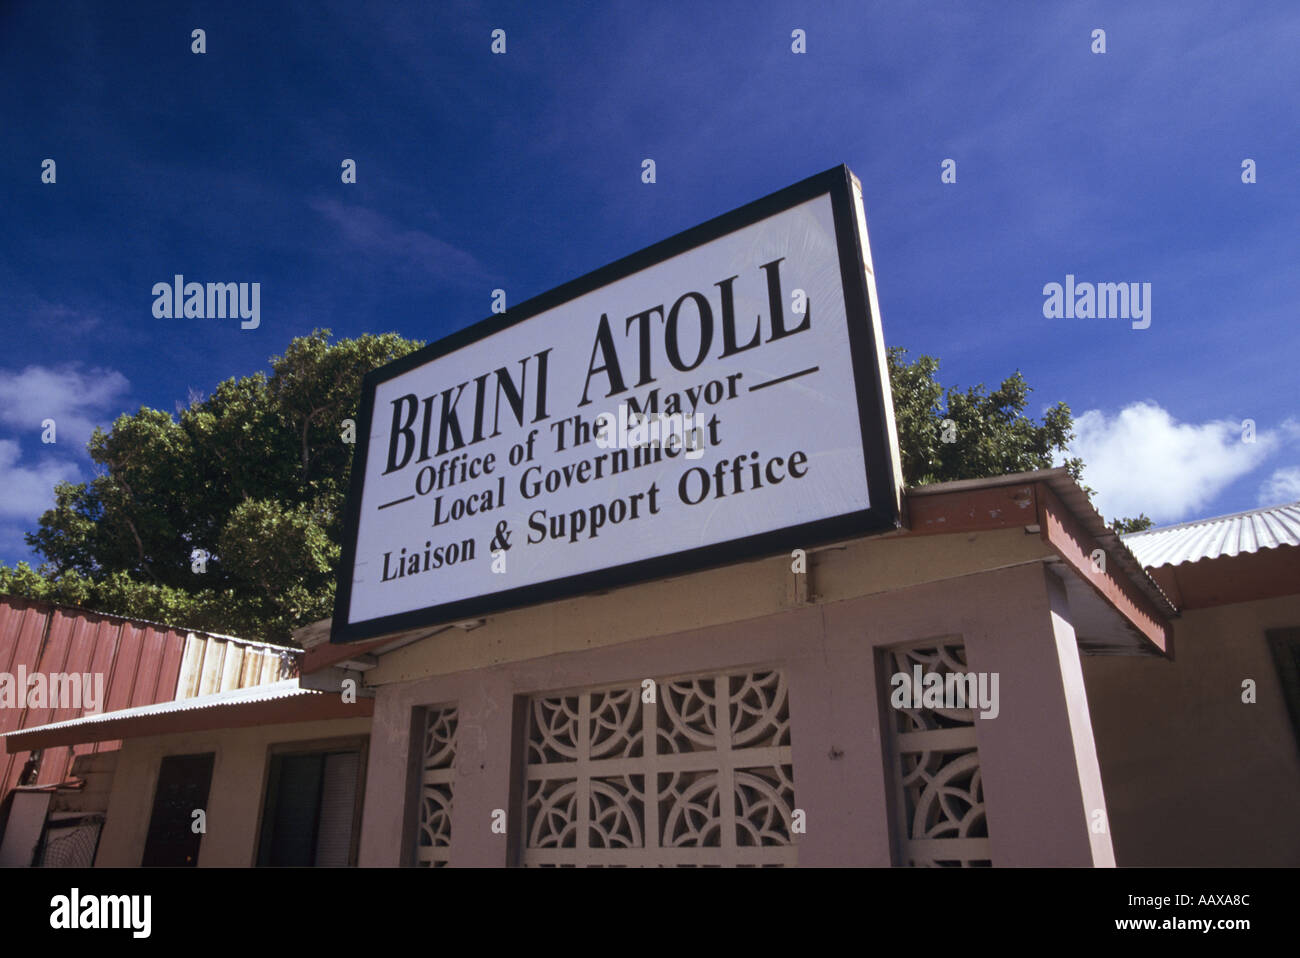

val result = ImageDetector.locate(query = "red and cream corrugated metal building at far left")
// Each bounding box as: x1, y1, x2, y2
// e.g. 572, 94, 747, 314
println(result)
0, 597, 325, 866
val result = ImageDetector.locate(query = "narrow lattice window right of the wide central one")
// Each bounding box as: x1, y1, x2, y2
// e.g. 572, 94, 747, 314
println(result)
884, 642, 992, 868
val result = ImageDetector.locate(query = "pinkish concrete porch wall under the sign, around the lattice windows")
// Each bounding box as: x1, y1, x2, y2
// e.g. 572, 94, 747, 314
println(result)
360, 556, 1113, 866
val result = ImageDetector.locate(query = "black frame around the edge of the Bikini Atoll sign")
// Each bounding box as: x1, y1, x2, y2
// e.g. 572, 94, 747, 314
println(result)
330, 165, 900, 643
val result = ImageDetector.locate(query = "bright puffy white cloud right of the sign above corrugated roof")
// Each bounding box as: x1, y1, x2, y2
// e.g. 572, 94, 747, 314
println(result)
1070, 402, 1279, 523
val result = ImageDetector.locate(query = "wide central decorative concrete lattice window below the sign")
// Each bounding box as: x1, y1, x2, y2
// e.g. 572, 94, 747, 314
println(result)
520, 671, 796, 867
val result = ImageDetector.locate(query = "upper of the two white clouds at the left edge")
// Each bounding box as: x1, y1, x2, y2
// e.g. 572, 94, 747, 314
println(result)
0, 364, 130, 454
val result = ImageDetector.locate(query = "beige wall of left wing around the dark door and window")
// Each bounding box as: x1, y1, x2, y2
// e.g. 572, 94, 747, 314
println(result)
95, 718, 371, 867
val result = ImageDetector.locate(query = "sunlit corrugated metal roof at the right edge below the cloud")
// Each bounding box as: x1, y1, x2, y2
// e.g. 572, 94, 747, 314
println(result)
1123, 500, 1300, 568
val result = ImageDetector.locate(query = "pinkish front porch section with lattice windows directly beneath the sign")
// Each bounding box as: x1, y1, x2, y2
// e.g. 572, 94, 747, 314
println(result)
298, 469, 1177, 866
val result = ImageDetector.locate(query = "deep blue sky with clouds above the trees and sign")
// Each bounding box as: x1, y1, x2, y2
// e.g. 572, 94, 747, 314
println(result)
0, 0, 1300, 563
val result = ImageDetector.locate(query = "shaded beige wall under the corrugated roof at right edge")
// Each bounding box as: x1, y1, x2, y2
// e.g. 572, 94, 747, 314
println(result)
1084, 595, 1300, 867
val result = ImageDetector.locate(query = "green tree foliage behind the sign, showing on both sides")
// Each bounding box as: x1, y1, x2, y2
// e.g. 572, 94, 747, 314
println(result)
0, 330, 1151, 641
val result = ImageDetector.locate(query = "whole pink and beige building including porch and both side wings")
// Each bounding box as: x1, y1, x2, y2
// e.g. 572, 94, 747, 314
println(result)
5, 486, 1300, 867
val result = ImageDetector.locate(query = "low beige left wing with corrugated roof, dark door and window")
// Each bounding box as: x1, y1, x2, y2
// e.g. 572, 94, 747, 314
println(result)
8, 677, 372, 868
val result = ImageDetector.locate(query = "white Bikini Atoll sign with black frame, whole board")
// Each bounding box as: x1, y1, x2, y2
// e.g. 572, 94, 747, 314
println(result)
332, 166, 901, 642
